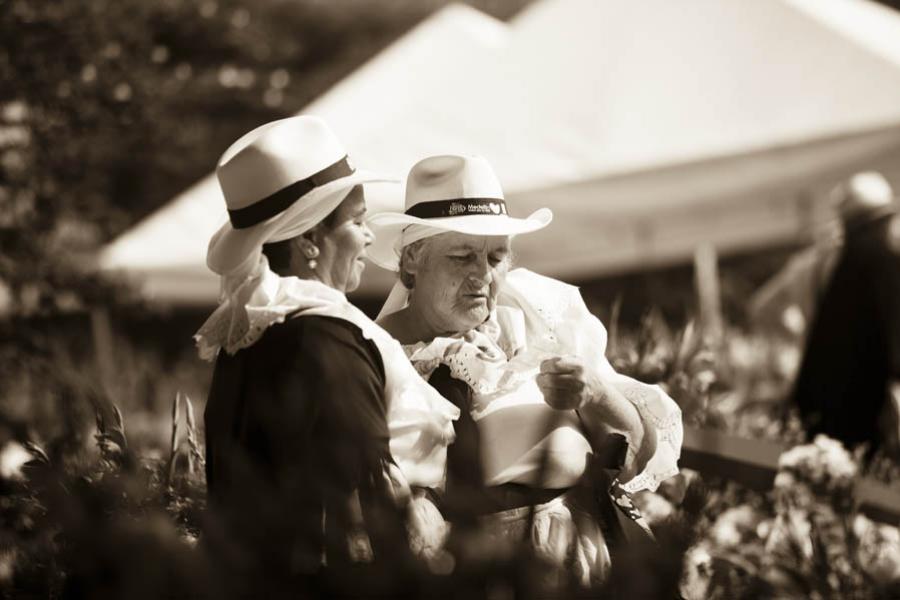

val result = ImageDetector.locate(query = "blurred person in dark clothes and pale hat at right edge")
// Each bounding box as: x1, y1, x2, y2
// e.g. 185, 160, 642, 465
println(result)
793, 172, 900, 455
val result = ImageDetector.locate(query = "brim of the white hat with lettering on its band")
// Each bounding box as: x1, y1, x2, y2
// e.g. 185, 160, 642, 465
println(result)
367, 208, 553, 271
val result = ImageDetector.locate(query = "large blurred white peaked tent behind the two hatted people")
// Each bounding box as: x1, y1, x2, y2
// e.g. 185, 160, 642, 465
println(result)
100, 0, 900, 304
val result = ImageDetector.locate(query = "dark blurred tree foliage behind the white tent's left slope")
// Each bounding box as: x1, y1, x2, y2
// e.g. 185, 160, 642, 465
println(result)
0, 0, 529, 315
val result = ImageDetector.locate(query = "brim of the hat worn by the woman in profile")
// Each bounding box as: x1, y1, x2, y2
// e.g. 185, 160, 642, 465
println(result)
206, 170, 399, 274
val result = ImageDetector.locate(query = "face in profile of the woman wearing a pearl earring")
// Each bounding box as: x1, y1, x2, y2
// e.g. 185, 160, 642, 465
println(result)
315, 186, 375, 293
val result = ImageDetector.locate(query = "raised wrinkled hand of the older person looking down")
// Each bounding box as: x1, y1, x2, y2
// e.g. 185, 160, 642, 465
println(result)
537, 356, 604, 410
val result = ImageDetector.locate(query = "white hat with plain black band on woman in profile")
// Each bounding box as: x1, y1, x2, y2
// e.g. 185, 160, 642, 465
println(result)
206, 115, 396, 275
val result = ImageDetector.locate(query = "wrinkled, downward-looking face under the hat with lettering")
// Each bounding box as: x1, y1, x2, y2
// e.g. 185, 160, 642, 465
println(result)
407, 232, 510, 335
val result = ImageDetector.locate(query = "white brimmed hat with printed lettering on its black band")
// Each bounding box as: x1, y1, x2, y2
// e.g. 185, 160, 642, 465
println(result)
368, 155, 553, 271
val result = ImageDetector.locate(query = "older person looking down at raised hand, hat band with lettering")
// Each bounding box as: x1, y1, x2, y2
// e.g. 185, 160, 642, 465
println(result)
369, 156, 682, 585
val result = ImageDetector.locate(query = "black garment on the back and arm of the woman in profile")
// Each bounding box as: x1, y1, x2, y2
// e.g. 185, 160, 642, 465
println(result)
205, 316, 404, 591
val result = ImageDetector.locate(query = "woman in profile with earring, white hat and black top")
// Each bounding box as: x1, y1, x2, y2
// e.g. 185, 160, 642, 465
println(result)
195, 116, 458, 594
